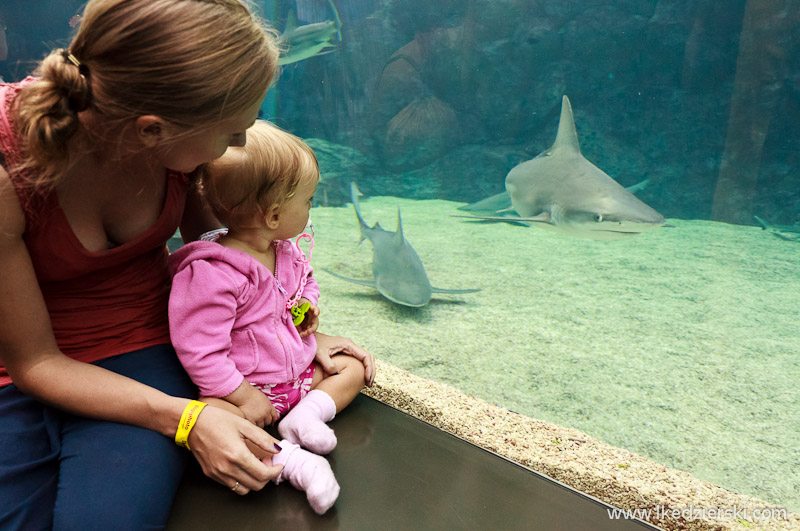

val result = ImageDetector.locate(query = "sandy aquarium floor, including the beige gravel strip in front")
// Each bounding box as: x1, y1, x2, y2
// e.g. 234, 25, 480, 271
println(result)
304, 197, 800, 529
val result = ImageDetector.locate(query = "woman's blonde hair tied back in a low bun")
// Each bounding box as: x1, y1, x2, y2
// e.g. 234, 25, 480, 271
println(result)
16, 0, 279, 190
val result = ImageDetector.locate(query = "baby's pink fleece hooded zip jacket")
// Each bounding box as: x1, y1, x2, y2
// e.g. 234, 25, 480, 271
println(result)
169, 240, 319, 397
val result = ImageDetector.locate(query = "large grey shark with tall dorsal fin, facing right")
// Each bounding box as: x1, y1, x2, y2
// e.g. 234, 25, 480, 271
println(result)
460, 95, 666, 240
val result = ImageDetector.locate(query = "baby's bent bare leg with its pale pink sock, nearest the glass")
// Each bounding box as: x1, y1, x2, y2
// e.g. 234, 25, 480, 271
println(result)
278, 355, 365, 454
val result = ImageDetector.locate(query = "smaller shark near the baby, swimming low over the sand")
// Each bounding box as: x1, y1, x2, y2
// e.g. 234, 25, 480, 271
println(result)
324, 183, 480, 308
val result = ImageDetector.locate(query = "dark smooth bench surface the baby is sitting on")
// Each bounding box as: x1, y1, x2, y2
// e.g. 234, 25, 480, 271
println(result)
167, 395, 657, 531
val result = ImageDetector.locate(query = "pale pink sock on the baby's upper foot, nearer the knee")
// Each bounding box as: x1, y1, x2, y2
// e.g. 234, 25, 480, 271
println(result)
278, 389, 336, 455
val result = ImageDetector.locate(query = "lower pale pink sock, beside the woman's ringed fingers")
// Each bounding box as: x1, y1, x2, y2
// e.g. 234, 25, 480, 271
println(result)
272, 439, 339, 514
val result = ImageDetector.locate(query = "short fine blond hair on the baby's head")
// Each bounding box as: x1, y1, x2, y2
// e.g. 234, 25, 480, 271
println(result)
201, 120, 319, 230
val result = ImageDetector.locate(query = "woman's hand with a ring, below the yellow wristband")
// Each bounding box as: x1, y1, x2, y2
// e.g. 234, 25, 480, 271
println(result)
189, 406, 283, 495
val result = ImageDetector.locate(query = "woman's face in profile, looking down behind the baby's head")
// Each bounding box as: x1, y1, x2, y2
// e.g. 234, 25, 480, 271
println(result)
161, 100, 261, 173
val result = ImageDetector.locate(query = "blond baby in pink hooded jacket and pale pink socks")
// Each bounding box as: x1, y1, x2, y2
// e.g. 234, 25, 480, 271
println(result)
169, 121, 375, 514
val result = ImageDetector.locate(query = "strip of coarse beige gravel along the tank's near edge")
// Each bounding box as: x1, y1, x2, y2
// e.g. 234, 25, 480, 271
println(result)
364, 360, 800, 531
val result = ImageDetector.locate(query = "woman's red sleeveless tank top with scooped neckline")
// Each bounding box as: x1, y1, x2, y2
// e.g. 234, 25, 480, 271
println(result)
0, 78, 189, 386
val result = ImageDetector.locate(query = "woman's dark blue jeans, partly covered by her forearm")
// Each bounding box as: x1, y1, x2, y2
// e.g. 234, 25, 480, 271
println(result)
0, 345, 197, 531
